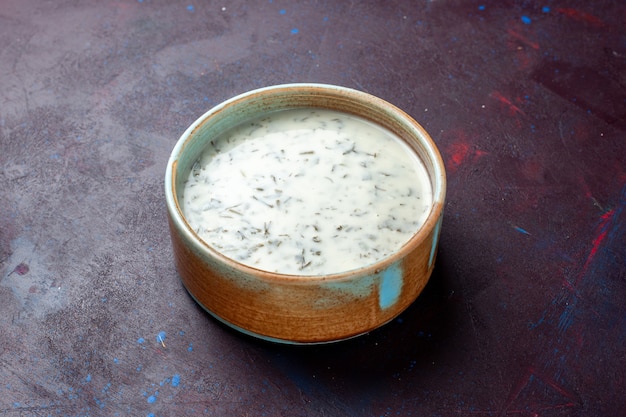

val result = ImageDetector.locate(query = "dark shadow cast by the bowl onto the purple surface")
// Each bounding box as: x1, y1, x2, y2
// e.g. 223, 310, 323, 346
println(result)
197, 247, 458, 403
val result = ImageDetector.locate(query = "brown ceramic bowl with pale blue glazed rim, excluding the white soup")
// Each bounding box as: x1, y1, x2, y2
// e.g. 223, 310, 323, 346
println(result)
165, 84, 446, 344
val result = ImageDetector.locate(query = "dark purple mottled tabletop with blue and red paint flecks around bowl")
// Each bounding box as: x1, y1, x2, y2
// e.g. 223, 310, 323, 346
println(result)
0, 0, 626, 417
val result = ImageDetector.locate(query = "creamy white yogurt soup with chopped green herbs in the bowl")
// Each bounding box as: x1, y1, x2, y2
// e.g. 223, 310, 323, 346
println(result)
179, 109, 432, 276
